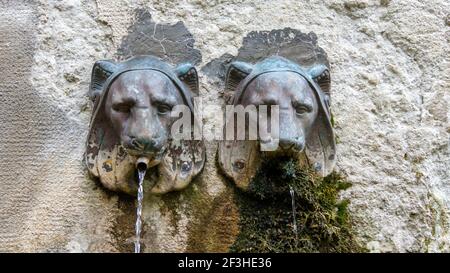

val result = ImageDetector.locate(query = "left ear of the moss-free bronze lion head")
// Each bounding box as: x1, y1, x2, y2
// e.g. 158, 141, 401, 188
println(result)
89, 60, 118, 101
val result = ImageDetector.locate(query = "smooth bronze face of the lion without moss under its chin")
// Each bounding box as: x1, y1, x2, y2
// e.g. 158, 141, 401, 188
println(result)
105, 70, 183, 160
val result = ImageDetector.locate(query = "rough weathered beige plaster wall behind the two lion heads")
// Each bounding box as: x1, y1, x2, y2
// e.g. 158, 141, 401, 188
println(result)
0, 0, 450, 252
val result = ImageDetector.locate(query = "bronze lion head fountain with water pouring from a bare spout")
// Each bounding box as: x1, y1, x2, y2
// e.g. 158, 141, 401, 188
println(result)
85, 56, 205, 195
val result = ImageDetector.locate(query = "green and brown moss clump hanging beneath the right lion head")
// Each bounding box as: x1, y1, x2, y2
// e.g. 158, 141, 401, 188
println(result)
230, 158, 365, 252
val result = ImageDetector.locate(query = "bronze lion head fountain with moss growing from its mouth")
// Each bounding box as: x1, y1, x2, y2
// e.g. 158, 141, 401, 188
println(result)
218, 56, 336, 190
